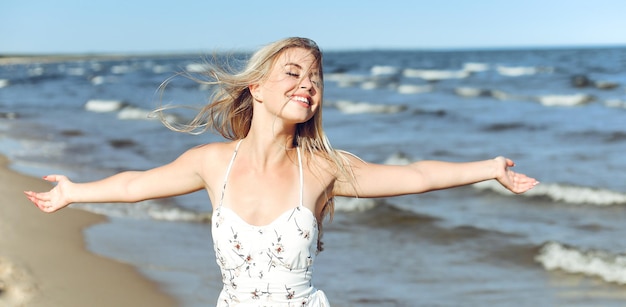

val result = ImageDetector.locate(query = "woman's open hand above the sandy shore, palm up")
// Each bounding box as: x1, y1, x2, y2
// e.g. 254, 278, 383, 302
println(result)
24, 175, 73, 213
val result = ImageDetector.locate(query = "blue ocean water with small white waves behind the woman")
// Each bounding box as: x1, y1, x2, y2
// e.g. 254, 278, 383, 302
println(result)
0, 47, 626, 307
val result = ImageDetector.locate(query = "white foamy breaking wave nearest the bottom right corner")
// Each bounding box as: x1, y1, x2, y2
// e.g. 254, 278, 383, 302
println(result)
535, 242, 626, 285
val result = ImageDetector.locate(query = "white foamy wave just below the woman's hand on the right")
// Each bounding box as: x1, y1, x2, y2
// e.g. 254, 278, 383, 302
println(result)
473, 180, 626, 206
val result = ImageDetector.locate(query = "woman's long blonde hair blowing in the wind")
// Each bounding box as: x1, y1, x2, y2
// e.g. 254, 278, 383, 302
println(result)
154, 37, 352, 251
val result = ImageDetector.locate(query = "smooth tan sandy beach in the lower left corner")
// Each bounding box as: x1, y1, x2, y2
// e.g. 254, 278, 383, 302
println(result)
0, 156, 176, 307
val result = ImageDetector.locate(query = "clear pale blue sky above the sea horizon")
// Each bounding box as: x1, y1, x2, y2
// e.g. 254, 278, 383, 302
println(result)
0, 0, 626, 54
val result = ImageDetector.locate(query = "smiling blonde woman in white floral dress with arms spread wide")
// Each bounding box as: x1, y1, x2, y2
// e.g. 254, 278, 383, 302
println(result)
25, 38, 538, 306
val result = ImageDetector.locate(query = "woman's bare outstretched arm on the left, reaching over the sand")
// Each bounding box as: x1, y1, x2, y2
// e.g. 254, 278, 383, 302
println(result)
24, 148, 205, 212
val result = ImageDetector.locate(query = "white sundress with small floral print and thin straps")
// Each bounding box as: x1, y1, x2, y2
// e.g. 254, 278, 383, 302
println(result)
212, 141, 330, 307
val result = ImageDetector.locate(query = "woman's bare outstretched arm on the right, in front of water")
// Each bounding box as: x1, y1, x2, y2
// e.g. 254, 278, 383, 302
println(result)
334, 155, 538, 197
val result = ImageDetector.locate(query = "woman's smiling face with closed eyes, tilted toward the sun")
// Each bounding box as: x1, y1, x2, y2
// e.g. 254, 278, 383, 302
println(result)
250, 48, 322, 124
